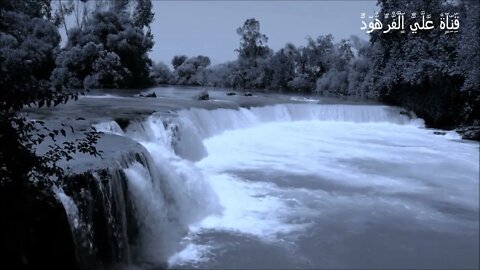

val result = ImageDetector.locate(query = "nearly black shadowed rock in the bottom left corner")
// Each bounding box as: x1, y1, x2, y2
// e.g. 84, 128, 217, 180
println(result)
0, 184, 79, 269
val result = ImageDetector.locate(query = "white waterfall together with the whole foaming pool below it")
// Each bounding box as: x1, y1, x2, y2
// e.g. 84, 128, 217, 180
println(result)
84, 103, 479, 269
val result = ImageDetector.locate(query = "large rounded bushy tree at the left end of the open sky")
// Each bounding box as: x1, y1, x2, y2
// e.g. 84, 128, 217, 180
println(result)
53, 7, 153, 88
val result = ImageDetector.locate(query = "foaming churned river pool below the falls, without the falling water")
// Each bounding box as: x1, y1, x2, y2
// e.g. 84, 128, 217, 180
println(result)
170, 113, 479, 268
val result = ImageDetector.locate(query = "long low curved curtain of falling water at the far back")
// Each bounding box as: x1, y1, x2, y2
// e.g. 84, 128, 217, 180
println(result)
178, 104, 421, 142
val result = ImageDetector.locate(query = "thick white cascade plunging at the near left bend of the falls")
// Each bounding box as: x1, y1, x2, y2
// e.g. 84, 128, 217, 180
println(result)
119, 115, 216, 263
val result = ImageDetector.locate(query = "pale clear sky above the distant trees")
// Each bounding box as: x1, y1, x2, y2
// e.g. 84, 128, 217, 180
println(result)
150, 0, 378, 64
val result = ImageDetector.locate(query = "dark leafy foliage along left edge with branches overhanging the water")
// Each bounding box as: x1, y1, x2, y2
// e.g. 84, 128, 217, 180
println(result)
0, 1, 99, 187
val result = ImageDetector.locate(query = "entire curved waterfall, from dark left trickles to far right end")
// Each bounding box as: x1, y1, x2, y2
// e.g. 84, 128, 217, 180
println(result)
57, 104, 422, 265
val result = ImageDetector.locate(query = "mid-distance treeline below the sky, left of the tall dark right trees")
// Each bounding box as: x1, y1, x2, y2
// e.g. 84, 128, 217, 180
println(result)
151, 18, 374, 97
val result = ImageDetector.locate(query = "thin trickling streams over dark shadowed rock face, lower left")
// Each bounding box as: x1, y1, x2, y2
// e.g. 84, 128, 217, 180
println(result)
53, 166, 138, 269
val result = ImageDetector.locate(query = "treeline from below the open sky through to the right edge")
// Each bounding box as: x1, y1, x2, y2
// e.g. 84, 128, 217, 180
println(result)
151, 0, 480, 133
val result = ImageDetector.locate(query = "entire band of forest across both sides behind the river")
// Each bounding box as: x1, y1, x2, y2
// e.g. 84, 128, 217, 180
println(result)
1, 0, 480, 133
